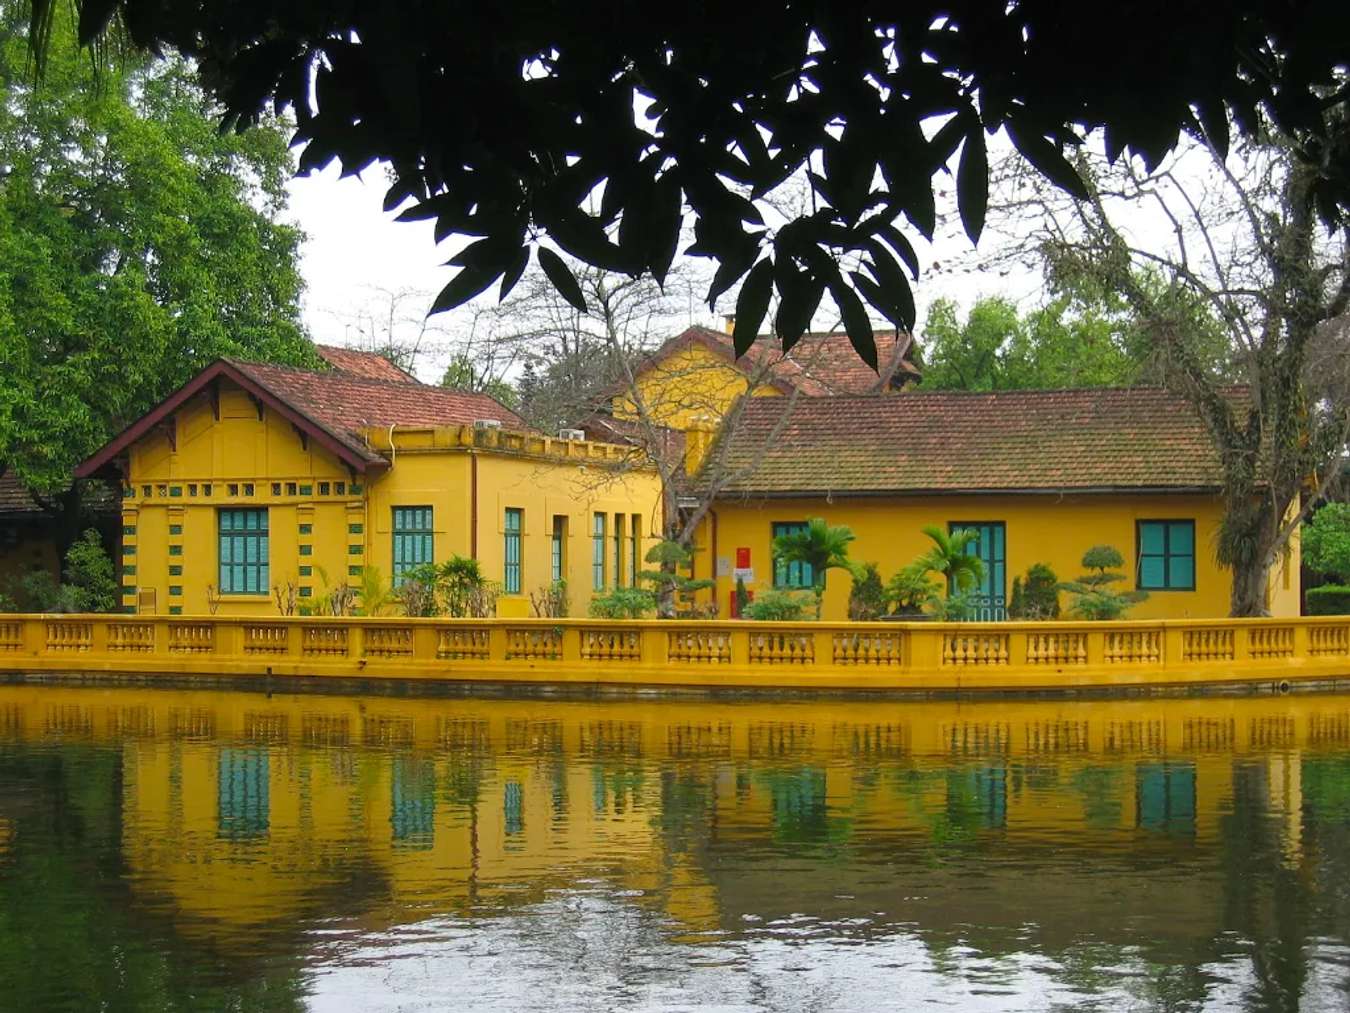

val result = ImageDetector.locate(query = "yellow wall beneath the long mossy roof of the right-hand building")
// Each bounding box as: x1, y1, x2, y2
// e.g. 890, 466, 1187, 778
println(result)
695, 496, 1299, 620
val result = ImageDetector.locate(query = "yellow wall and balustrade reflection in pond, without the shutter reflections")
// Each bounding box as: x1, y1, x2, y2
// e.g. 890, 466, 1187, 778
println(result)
0, 686, 1328, 947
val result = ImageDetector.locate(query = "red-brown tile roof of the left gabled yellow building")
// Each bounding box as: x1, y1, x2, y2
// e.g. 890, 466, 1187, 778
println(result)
76, 359, 532, 478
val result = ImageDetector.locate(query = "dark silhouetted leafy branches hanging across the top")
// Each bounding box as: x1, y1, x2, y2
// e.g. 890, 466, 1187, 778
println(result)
32, 0, 1350, 365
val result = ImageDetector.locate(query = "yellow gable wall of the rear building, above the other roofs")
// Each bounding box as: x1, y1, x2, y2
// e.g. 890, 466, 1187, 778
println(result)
613, 344, 780, 430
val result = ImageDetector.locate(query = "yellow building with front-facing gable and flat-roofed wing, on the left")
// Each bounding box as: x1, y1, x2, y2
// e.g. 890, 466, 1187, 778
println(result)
77, 361, 659, 616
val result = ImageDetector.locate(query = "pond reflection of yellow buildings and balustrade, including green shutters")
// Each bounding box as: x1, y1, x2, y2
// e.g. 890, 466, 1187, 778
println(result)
0, 686, 1350, 944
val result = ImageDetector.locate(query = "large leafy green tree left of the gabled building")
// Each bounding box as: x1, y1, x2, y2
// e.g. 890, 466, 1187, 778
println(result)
0, 4, 312, 494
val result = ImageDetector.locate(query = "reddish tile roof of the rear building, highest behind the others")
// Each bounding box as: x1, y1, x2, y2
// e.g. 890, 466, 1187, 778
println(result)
648, 327, 919, 397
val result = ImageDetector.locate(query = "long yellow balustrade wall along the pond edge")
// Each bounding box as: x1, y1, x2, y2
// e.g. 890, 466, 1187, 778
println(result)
0, 616, 1350, 693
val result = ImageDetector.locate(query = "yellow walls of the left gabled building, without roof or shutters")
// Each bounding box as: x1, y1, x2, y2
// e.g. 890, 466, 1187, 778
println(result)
123, 384, 659, 616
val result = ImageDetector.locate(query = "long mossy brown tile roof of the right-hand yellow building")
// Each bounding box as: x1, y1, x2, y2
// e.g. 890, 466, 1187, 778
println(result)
711, 388, 1220, 497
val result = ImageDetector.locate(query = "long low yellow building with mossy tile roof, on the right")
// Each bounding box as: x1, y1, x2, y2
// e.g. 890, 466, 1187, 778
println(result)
697, 388, 1299, 620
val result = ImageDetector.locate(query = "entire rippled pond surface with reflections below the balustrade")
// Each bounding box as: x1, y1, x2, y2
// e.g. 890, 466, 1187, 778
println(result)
0, 686, 1350, 1013
